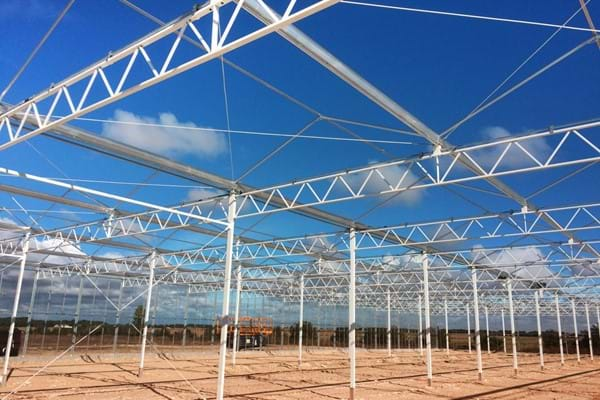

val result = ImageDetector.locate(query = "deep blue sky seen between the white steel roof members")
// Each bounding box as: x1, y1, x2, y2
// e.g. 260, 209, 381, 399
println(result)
0, 0, 600, 330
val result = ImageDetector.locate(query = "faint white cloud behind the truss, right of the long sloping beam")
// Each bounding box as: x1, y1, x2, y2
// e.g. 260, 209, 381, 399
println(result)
473, 126, 551, 169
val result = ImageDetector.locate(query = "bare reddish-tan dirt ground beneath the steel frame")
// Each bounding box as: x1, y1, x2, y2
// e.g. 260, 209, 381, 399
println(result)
0, 347, 600, 400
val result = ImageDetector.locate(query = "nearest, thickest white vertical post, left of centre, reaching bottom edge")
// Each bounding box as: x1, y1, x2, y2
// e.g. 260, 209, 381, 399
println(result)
213, 191, 237, 400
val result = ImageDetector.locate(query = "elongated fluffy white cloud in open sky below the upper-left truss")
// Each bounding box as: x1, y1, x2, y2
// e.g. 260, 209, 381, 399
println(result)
102, 110, 227, 158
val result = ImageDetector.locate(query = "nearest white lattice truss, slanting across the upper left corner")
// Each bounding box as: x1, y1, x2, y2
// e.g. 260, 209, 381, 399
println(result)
0, 0, 339, 150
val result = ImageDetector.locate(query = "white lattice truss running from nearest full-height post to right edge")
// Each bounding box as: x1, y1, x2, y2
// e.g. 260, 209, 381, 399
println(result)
237, 121, 600, 218
